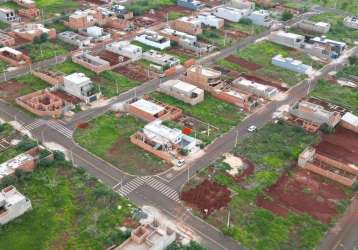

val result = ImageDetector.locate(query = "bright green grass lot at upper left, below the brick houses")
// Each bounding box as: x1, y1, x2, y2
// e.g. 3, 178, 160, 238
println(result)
21, 41, 68, 63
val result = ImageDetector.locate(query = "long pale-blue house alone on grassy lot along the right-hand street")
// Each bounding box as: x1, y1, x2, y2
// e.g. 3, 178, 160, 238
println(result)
272, 55, 313, 75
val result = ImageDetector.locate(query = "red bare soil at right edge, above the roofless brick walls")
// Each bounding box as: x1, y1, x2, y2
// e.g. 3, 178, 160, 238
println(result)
316, 126, 358, 164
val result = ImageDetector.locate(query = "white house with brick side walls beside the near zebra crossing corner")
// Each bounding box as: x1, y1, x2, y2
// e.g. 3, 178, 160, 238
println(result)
130, 119, 201, 166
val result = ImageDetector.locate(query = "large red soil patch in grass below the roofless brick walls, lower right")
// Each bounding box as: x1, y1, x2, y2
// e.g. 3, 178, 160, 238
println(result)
256, 169, 349, 223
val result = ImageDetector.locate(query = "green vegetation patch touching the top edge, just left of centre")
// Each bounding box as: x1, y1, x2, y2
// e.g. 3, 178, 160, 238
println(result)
126, 0, 176, 16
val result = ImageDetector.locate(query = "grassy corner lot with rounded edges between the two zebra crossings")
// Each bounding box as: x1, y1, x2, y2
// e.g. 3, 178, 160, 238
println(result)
74, 113, 169, 175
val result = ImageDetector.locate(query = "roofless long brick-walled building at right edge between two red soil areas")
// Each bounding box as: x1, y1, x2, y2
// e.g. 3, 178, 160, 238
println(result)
298, 147, 358, 187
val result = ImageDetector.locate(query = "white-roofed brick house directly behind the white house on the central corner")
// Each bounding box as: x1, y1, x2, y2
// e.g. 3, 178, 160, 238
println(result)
128, 98, 182, 122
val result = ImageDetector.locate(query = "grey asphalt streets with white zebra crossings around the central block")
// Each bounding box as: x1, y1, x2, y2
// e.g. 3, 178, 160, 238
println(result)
0, 11, 358, 249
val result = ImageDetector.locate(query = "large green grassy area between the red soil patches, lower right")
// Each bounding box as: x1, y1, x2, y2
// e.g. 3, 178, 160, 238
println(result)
185, 122, 328, 249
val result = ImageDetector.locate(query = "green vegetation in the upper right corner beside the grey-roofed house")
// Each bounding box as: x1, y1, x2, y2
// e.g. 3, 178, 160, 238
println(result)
310, 12, 358, 44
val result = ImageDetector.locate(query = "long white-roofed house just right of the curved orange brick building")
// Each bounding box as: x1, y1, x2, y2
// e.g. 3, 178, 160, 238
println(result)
232, 77, 278, 99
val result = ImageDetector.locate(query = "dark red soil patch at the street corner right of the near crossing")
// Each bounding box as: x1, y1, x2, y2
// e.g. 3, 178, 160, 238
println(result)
180, 179, 231, 216
